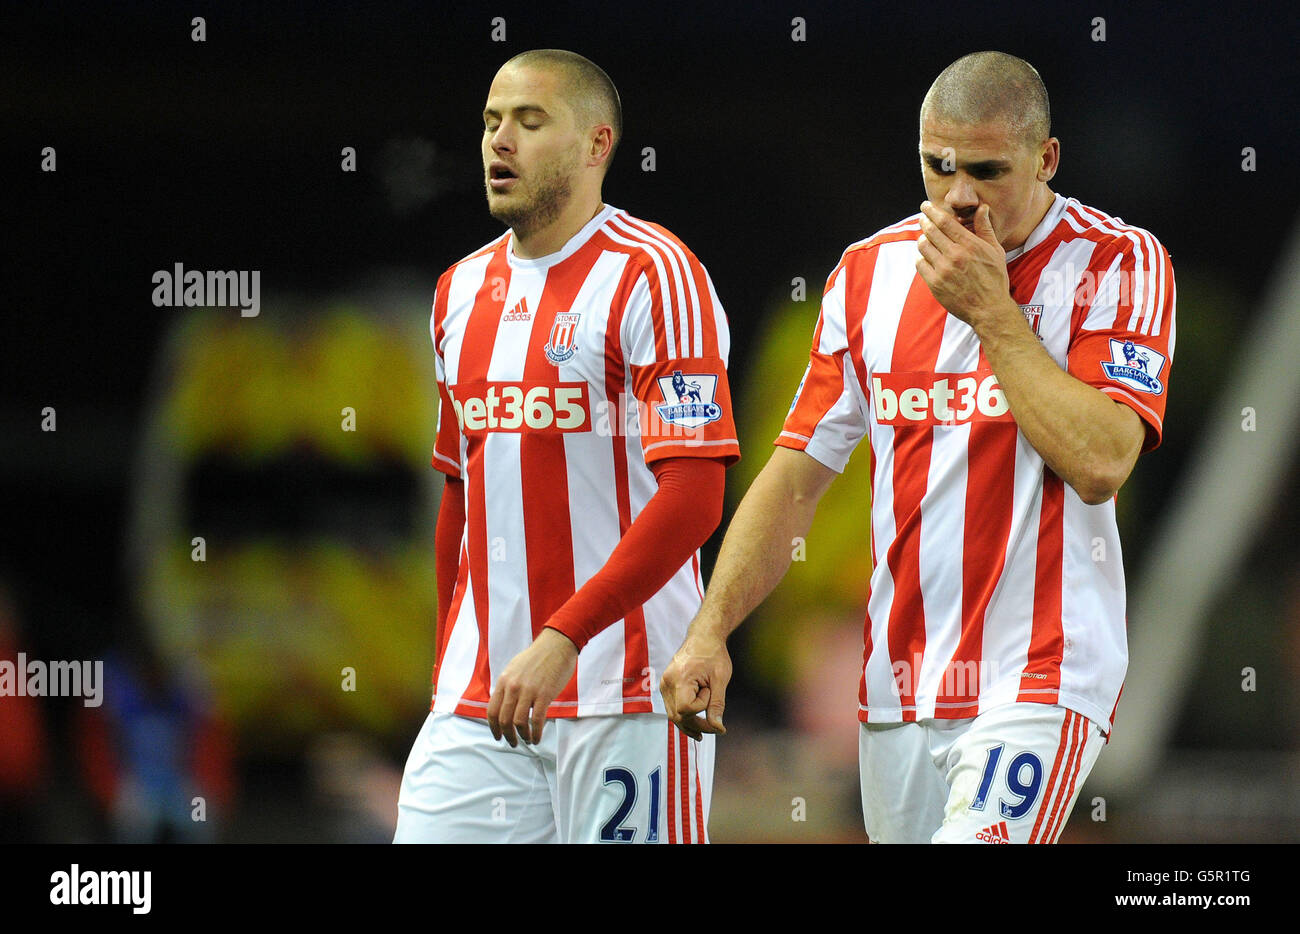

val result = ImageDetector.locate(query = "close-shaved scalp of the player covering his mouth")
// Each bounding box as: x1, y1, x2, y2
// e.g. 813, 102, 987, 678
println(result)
920, 52, 1052, 146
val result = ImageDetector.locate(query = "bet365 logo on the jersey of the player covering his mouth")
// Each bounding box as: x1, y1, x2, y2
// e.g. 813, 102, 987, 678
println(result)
871, 369, 1015, 428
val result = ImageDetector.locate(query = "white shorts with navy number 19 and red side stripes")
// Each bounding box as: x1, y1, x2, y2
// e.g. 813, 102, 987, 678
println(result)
858, 704, 1105, 843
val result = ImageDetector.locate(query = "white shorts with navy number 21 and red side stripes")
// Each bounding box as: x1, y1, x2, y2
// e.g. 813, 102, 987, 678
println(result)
393, 713, 714, 843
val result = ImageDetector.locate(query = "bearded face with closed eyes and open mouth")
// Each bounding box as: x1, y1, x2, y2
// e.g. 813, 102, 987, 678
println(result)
482, 66, 582, 233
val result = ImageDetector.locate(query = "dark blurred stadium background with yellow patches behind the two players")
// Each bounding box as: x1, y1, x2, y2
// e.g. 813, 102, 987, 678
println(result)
0, 1, 1300, 842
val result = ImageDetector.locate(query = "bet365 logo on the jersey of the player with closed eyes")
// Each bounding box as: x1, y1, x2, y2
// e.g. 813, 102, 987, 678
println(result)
447, 382, 592, 434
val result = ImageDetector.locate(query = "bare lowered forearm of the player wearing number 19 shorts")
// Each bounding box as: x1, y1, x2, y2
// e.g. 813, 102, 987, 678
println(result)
688, 447, 835, 640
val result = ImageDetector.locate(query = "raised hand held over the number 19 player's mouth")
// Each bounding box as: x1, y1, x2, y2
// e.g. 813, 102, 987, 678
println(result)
917, 202, 1019, 330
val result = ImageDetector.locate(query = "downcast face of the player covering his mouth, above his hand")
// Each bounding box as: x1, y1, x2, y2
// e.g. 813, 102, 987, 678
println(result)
920, 114, 1060, 250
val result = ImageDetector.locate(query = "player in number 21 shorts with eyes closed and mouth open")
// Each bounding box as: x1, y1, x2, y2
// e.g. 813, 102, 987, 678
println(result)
395, 49, 740, 843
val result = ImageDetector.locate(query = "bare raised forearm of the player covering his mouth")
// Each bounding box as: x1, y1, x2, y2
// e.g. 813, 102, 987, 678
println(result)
976, 299, 1144, 505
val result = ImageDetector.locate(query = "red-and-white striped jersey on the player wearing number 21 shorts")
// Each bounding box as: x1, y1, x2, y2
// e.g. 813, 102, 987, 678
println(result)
430, 206, 740, 717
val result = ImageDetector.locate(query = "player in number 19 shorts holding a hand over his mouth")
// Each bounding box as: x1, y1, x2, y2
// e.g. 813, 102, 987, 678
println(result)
662, 52, 1174, 843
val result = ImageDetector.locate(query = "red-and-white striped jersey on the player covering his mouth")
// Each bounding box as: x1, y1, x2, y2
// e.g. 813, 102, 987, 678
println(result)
776, 195, 1175, 732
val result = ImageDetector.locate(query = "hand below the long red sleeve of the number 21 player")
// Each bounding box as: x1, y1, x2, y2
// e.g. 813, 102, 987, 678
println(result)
488, 630, 577, 747
